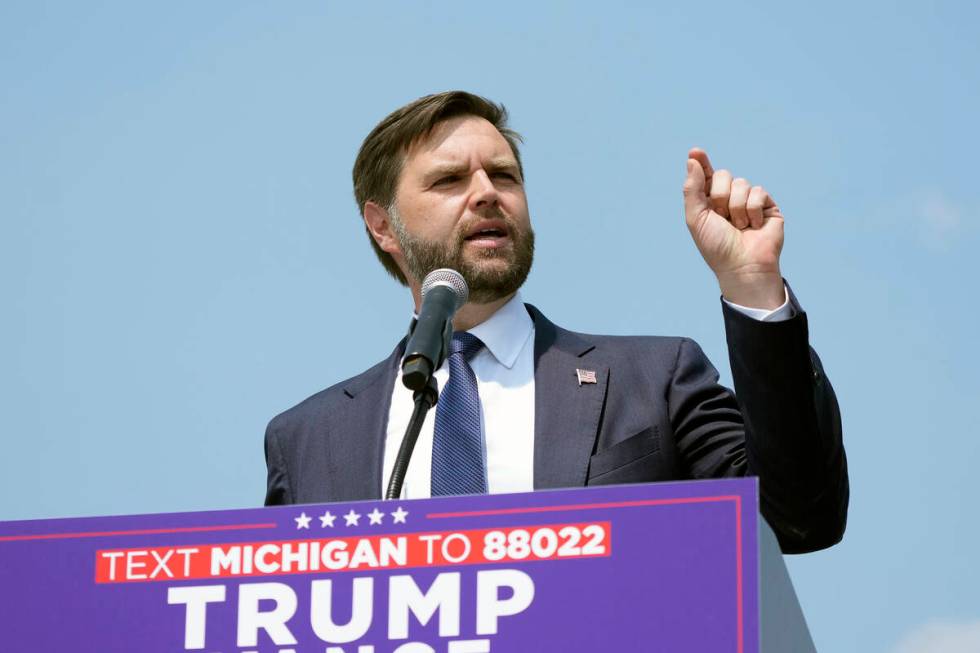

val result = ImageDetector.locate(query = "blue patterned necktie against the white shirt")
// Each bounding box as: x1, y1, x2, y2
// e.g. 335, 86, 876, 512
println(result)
431, 331, 487, 497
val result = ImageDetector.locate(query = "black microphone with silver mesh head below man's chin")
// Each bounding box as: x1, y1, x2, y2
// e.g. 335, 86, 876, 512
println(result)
402, 268, 470, 391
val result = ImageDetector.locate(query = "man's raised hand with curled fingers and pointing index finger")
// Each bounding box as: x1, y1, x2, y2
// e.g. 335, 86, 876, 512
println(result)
684, 148, 785, 309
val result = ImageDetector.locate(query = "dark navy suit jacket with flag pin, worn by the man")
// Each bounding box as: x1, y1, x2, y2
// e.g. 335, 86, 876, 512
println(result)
265, 305, 848, 553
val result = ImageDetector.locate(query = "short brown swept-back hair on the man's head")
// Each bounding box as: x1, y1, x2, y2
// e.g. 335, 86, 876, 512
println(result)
353, 91, 524, 286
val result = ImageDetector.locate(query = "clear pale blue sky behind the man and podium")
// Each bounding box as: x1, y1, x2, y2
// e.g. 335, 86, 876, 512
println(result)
0, 0, 980, 653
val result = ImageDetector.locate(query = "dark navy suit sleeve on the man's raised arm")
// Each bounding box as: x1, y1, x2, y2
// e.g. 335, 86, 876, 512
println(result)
668, 306, 849, 553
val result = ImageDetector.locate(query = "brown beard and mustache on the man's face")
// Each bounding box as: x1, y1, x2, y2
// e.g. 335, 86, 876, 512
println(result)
388, 206, 534, 304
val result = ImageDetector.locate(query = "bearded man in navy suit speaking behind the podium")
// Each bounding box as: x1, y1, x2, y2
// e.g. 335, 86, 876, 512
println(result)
265, 92, 848, 552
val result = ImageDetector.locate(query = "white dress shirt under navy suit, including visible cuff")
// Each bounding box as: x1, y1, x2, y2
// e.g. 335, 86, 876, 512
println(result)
381, 293, 796, 499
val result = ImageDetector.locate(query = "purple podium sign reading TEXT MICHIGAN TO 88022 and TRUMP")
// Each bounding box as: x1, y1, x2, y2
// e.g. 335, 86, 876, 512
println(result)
0, 479, 780, 653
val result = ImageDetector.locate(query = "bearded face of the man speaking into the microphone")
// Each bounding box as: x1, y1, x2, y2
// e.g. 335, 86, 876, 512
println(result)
389, 116, 534, 304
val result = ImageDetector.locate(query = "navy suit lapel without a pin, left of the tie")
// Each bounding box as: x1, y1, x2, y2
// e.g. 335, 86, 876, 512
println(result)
333, 340, 405, 499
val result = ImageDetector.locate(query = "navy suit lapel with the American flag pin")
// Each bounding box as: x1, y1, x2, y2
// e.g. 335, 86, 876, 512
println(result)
528, 305, 609, 490
